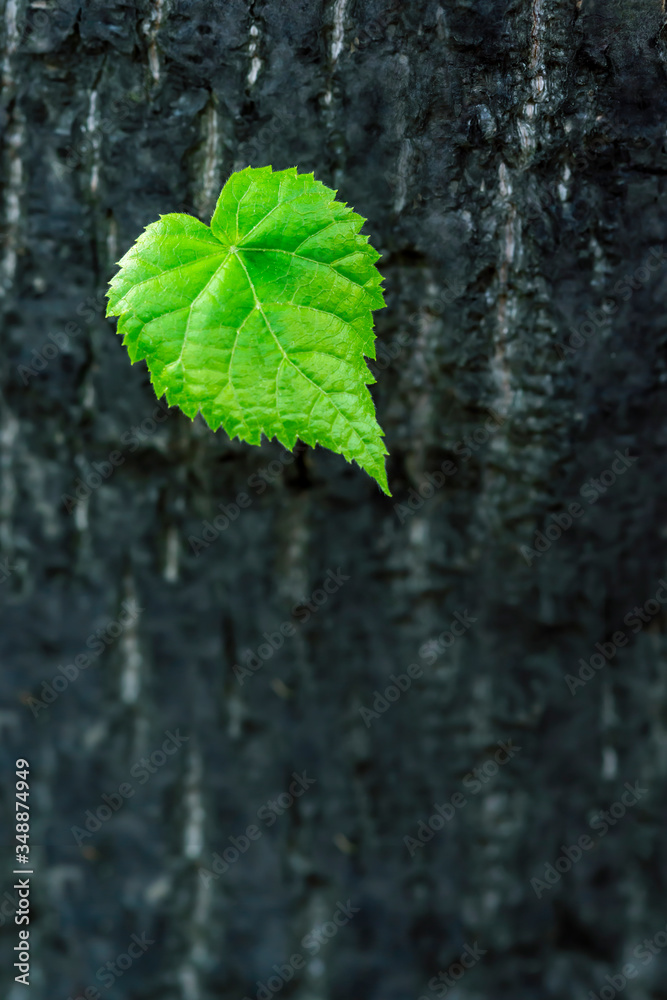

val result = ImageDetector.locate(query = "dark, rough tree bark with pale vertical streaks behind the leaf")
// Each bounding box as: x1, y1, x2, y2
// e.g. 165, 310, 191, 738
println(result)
0, 0, 667, 1000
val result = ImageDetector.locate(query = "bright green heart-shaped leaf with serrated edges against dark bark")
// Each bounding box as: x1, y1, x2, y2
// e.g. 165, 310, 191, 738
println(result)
107, 167, 391, 495
